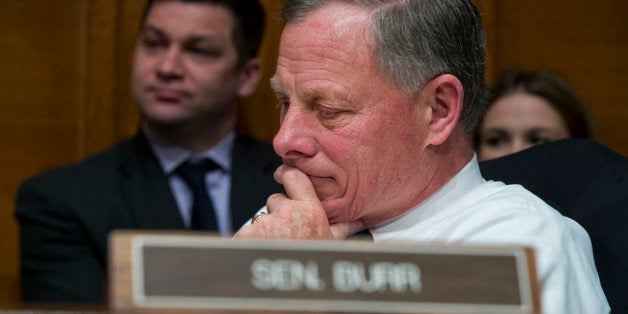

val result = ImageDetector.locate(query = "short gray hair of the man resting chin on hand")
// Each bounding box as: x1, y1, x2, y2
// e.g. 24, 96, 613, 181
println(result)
281, 0, 486, 134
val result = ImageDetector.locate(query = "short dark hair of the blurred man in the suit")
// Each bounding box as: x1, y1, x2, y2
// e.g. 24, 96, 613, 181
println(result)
142, 0, 266, 64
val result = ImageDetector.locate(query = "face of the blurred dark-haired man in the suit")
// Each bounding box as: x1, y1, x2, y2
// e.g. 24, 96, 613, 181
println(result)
132, 1, 246, 126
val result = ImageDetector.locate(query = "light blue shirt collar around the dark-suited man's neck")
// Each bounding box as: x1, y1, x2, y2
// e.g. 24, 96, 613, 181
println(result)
143, 128, 235, 174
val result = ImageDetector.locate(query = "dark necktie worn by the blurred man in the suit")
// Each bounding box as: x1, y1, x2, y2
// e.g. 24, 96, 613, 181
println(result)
175, 159, 220, 231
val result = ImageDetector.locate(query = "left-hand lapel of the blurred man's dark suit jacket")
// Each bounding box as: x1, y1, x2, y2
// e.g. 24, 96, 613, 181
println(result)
118, 132, 185, 229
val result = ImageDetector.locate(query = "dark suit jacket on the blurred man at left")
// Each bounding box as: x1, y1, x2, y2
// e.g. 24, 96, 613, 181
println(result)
16, 132, 283, 303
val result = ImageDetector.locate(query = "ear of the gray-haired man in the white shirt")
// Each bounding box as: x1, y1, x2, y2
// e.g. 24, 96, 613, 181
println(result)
423, 74, 464, 145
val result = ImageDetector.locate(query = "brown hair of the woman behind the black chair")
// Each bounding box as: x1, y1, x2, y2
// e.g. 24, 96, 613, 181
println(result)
487, 68, 593, 139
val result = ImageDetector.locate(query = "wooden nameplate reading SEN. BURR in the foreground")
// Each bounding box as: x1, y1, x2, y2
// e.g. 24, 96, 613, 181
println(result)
110, 232, 538, 313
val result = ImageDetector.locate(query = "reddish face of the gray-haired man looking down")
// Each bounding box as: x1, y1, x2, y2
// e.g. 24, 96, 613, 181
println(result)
272, 5, 429, 224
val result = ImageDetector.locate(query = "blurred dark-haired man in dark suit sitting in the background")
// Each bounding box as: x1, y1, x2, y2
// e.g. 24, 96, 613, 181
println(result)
16, 0, 282, 303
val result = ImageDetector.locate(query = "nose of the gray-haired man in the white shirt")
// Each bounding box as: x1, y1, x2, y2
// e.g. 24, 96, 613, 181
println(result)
273, 106, 316, 160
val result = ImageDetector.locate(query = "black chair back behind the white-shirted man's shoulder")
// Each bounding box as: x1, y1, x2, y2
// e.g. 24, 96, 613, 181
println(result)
480, 139, 628, 313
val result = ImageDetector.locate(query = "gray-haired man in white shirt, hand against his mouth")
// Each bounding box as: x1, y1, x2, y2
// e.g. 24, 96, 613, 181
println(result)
236, 0, 609, 313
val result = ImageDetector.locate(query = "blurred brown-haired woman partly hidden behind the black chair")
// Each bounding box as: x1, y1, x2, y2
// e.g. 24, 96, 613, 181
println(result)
475, 68, 593, 160
